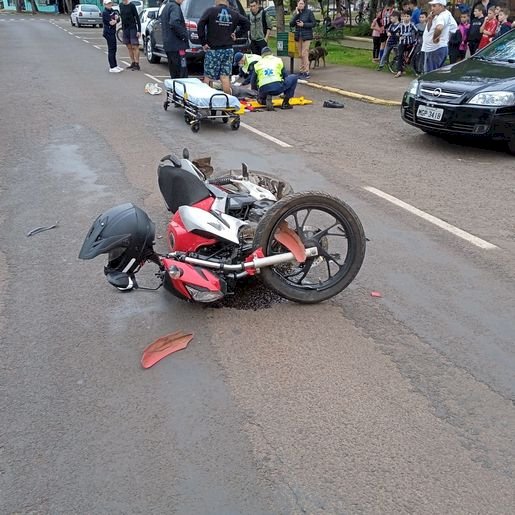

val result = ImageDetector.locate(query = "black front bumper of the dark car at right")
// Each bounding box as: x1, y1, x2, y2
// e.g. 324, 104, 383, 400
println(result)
401, 93, 515, 141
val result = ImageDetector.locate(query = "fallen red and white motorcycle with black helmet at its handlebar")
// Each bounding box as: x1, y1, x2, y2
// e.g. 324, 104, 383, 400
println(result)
79, 150, 366, 304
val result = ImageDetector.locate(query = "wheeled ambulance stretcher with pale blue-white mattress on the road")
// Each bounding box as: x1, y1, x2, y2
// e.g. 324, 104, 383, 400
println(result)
163, 78, 241, 132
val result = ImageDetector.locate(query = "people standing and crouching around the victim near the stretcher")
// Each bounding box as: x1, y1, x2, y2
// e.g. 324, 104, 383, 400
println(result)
102, 0, 316, 110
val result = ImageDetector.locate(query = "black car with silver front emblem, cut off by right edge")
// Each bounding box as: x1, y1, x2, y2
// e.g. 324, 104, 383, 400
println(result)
401, 30, 515, 153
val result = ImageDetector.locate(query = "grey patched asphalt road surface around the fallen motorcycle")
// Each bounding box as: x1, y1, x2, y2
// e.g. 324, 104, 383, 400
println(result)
0, 15, 515, 514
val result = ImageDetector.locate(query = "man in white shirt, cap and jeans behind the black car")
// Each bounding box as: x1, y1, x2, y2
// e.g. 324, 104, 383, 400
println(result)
422, 0, 458, 73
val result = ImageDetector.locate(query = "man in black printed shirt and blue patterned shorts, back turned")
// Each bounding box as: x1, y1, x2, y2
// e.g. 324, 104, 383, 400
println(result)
197, 0, 250, 94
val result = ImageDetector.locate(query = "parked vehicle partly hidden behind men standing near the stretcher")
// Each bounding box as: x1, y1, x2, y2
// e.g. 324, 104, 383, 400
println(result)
145, 0, 249, 63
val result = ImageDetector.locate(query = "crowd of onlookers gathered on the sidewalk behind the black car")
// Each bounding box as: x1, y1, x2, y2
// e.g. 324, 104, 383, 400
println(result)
371, 0, 515, 77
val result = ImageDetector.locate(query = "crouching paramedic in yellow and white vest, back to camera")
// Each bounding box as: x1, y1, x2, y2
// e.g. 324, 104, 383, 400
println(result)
250, 47, 298, 111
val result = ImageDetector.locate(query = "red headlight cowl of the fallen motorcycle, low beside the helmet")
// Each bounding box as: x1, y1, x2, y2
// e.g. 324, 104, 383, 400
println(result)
162, 258, 226, 300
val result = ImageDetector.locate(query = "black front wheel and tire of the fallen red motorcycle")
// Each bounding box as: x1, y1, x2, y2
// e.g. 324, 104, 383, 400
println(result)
254, 192, 366, 304
